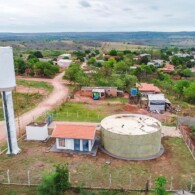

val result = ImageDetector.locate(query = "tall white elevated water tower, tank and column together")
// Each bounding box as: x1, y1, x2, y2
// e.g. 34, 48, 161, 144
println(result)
0, 47, 20, 155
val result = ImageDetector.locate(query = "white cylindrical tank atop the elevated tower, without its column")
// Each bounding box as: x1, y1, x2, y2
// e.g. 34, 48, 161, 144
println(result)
0, 47, 16, 91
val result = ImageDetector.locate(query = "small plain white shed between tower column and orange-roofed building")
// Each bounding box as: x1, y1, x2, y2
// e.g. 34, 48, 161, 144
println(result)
26, 123, 48, 141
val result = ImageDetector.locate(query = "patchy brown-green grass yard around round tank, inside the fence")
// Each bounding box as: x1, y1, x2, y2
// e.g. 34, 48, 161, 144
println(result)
0, 137, 195, 190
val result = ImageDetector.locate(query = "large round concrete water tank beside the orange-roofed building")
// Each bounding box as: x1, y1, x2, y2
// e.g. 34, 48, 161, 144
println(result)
101, 114, 164, 160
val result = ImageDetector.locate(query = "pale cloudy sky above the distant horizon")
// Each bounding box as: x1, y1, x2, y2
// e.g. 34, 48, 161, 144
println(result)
0, 0, 195, 32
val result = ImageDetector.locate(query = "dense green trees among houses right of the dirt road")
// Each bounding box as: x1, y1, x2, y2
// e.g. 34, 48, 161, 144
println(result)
64, 48, 195, 104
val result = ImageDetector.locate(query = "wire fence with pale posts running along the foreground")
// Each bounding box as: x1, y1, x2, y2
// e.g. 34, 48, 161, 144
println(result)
0, 169, 195, 191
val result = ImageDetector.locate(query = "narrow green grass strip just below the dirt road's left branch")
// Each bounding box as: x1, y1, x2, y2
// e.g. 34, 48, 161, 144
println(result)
17, 80, 53, 92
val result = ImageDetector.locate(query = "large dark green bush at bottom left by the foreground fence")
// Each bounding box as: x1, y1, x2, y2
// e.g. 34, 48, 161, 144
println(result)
38, 164, 71, 195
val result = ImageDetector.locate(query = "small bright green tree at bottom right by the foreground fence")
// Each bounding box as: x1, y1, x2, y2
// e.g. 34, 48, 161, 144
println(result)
154, 176, 168, 195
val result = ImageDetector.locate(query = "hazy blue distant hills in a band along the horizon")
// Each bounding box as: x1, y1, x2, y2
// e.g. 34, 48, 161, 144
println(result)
0, 32, 195, 47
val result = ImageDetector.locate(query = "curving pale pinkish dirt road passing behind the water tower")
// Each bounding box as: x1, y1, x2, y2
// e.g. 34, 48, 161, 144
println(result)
0, 73, 68, 142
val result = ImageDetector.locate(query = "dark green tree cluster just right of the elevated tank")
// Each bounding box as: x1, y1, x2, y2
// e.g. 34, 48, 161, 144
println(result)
14, 51, 59, 77
